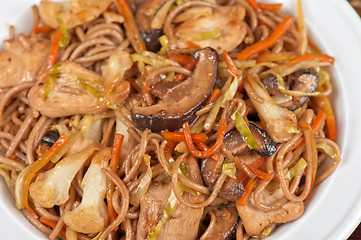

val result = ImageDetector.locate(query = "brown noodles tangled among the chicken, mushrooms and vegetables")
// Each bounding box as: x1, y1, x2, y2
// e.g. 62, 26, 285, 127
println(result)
0, 0, 340, 239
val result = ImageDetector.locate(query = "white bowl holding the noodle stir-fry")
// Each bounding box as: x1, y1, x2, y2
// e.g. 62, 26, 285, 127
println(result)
0, 0, 361, 240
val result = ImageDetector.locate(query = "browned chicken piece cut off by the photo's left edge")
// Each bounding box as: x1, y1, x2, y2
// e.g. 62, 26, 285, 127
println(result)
0, 34, 50, 88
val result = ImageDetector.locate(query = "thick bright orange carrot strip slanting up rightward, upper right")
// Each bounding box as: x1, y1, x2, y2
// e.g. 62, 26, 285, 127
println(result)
237, 16, 295, 60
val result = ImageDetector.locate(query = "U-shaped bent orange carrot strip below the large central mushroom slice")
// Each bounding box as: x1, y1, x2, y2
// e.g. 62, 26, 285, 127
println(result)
183, 118, 227, 158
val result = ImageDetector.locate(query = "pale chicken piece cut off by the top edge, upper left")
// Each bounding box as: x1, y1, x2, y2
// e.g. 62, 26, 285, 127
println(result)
39, 0, 112, 29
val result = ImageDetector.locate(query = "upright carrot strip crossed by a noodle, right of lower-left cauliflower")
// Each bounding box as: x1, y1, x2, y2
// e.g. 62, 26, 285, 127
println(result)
107, 133, 124, 228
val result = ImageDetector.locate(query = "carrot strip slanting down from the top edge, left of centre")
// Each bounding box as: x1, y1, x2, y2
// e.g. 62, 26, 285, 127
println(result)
118, 0, 147, 52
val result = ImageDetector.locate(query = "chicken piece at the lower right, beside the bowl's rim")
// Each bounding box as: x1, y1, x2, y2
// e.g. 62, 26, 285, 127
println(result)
237, 190, 304, 236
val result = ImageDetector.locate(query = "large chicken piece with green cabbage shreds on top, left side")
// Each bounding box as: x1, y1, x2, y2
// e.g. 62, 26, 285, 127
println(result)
28, 61, 108, 118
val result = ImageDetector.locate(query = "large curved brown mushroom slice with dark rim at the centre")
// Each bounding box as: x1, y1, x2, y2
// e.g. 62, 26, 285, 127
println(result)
131, 48, 218, 132
